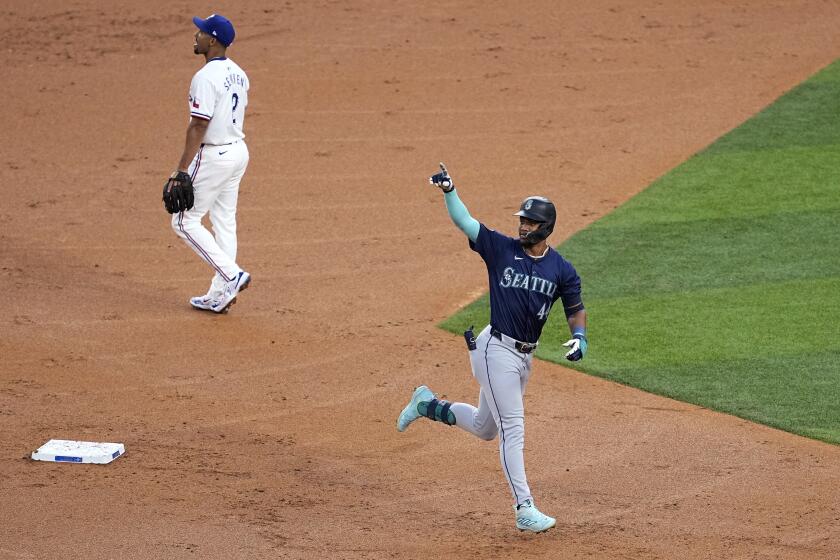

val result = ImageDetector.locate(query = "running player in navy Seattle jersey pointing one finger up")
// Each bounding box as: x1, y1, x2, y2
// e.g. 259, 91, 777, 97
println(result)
397, 164, 587, 533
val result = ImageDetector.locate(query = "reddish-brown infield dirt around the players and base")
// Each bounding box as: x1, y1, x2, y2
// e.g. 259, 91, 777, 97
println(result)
0, 0, 840, 560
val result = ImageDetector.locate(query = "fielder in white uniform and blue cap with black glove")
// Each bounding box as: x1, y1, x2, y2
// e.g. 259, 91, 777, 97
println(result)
164, 14, 251, 313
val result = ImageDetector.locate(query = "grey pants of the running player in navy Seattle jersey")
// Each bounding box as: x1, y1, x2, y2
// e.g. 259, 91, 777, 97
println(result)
449, 325, 533, 505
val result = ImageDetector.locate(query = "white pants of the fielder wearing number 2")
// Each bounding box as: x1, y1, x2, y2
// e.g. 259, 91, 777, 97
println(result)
172, 140, 249, 295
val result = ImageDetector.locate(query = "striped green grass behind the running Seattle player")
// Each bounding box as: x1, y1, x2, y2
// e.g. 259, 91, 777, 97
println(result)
441, 57, 840, 443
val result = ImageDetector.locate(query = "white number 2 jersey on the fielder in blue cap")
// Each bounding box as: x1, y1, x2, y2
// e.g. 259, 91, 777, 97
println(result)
190, 57, 249, 146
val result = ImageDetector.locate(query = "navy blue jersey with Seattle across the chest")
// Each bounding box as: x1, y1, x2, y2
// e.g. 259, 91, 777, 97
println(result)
470, 224, 583, 343
